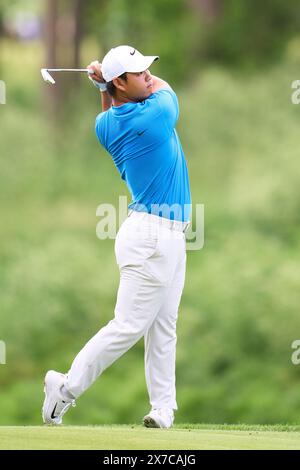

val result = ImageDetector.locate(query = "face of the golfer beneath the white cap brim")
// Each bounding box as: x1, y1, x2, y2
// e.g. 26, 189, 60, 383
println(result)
118, 69, 153, 102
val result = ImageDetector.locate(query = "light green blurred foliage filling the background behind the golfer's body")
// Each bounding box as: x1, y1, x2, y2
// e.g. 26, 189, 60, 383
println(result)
0, 36, 300, 424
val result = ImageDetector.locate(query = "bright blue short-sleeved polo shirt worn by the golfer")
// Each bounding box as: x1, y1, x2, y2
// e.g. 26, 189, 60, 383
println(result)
96, 89, 191, 221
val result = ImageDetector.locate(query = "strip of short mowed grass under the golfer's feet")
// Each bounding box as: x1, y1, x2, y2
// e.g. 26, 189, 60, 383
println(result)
0, 425, 300, 450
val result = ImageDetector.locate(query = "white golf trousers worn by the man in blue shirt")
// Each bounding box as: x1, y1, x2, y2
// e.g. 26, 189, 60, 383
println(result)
65, 211, 186, 409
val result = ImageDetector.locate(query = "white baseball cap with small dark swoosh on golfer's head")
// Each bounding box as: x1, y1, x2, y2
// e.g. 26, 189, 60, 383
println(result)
101, 46, 159, 82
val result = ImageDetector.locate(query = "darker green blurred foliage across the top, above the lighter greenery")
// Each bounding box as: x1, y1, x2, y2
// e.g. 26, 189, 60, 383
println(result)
0, 0, 300, 84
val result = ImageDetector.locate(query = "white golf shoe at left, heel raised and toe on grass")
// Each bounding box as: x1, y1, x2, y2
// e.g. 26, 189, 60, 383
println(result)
42, 370, 75, 425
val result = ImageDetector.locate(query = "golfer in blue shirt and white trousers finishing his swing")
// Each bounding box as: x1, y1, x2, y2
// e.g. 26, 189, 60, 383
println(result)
42, 46, 191, 428
